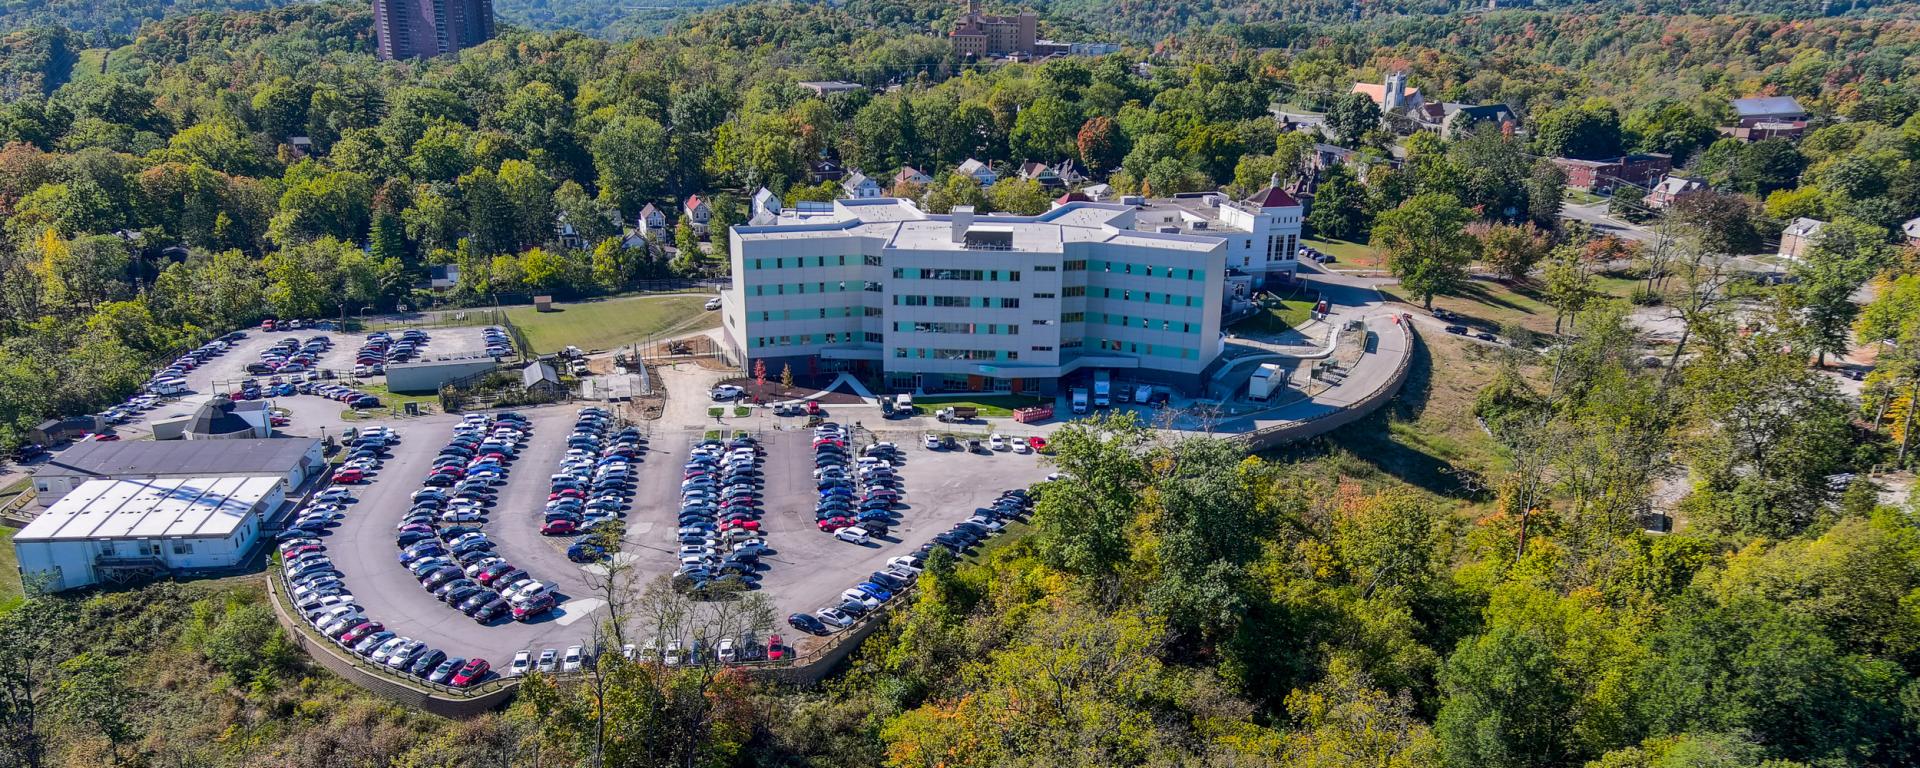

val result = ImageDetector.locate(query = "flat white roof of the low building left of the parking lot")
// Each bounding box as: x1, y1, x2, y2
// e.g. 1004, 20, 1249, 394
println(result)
13, 476, 280, 541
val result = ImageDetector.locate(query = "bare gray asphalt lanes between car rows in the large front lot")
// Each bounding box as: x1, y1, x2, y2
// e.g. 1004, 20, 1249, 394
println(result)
301, 405, 1048, 668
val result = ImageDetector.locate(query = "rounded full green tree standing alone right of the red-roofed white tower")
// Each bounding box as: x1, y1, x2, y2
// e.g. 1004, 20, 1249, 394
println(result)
1369, 192, 1478, 309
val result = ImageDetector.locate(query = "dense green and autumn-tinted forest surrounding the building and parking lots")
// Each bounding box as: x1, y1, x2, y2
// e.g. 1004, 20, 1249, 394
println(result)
0, 0, 1920, 768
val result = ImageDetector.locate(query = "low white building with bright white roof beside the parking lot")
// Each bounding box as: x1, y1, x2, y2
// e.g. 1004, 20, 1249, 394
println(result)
13, 476, 286, 591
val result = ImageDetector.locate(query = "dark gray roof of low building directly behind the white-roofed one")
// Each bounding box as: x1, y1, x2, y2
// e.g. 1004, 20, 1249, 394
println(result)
33, 438, 321, 478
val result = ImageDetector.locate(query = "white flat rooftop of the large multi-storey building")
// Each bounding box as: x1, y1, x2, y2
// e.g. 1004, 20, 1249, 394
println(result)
733, 198, 1221, 253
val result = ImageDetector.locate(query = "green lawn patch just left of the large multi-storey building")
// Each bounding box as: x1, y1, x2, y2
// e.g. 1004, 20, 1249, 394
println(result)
507, 294, 720, 353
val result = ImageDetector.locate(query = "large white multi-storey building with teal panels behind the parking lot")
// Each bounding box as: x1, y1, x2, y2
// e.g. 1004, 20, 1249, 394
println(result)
722, 192, 1227, 394
